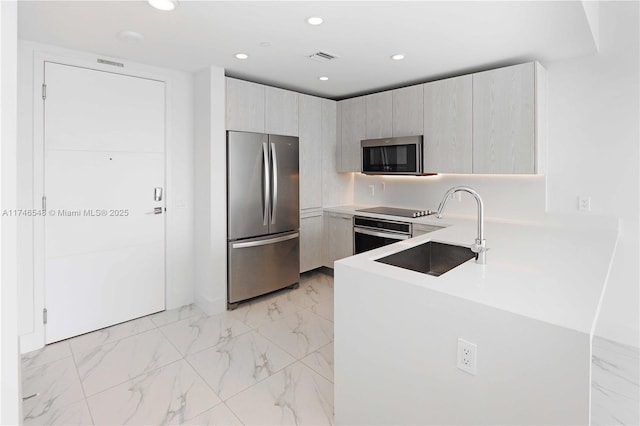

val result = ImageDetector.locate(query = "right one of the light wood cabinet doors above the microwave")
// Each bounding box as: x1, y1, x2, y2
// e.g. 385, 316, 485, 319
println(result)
392, 84, 424, 137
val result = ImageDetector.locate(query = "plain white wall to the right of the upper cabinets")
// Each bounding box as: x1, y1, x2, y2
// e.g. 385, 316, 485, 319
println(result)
545, 1, 640, 347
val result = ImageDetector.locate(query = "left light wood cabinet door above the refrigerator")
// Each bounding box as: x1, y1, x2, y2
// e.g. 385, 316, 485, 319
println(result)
226, 78, 265, 133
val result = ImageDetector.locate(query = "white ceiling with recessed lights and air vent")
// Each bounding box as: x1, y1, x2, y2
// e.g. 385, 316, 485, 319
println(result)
18, 0, 596, 99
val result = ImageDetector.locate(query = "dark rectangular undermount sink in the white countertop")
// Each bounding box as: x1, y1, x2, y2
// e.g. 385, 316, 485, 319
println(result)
376, 241, 476, 277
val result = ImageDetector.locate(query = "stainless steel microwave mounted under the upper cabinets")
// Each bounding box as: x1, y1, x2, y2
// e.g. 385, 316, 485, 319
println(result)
360, 136, 424, 175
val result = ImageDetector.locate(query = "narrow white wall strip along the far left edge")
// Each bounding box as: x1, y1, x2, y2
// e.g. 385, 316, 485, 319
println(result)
0, 2, 22, 425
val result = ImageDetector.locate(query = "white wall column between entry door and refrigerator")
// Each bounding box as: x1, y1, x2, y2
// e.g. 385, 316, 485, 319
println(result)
195, 67, 227, 314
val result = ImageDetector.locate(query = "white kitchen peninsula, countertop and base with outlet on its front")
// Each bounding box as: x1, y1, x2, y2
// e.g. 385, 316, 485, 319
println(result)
325, 206, 618, 424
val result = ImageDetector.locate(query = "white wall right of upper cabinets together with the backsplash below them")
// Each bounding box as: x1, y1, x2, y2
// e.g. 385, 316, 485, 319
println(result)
354, 2, 640, 347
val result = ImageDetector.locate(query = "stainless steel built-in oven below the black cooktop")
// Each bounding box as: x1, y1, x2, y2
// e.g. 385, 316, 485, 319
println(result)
353, 216, 411, 254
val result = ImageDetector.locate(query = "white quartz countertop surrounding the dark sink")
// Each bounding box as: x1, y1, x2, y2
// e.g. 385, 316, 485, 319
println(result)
324, 206, 618, 334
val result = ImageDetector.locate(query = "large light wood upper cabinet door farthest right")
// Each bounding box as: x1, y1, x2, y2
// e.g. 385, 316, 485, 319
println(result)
473, 62, 535, 174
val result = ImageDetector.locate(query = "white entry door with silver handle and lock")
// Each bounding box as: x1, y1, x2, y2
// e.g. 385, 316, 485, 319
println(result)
44, 62, 165, 343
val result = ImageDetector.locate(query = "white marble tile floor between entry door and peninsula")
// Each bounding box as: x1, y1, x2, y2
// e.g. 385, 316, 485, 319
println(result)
22, 271, 333, 425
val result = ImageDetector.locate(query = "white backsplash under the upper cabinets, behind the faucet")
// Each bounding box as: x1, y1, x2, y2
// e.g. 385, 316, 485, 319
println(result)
353, 173, 546, 220
